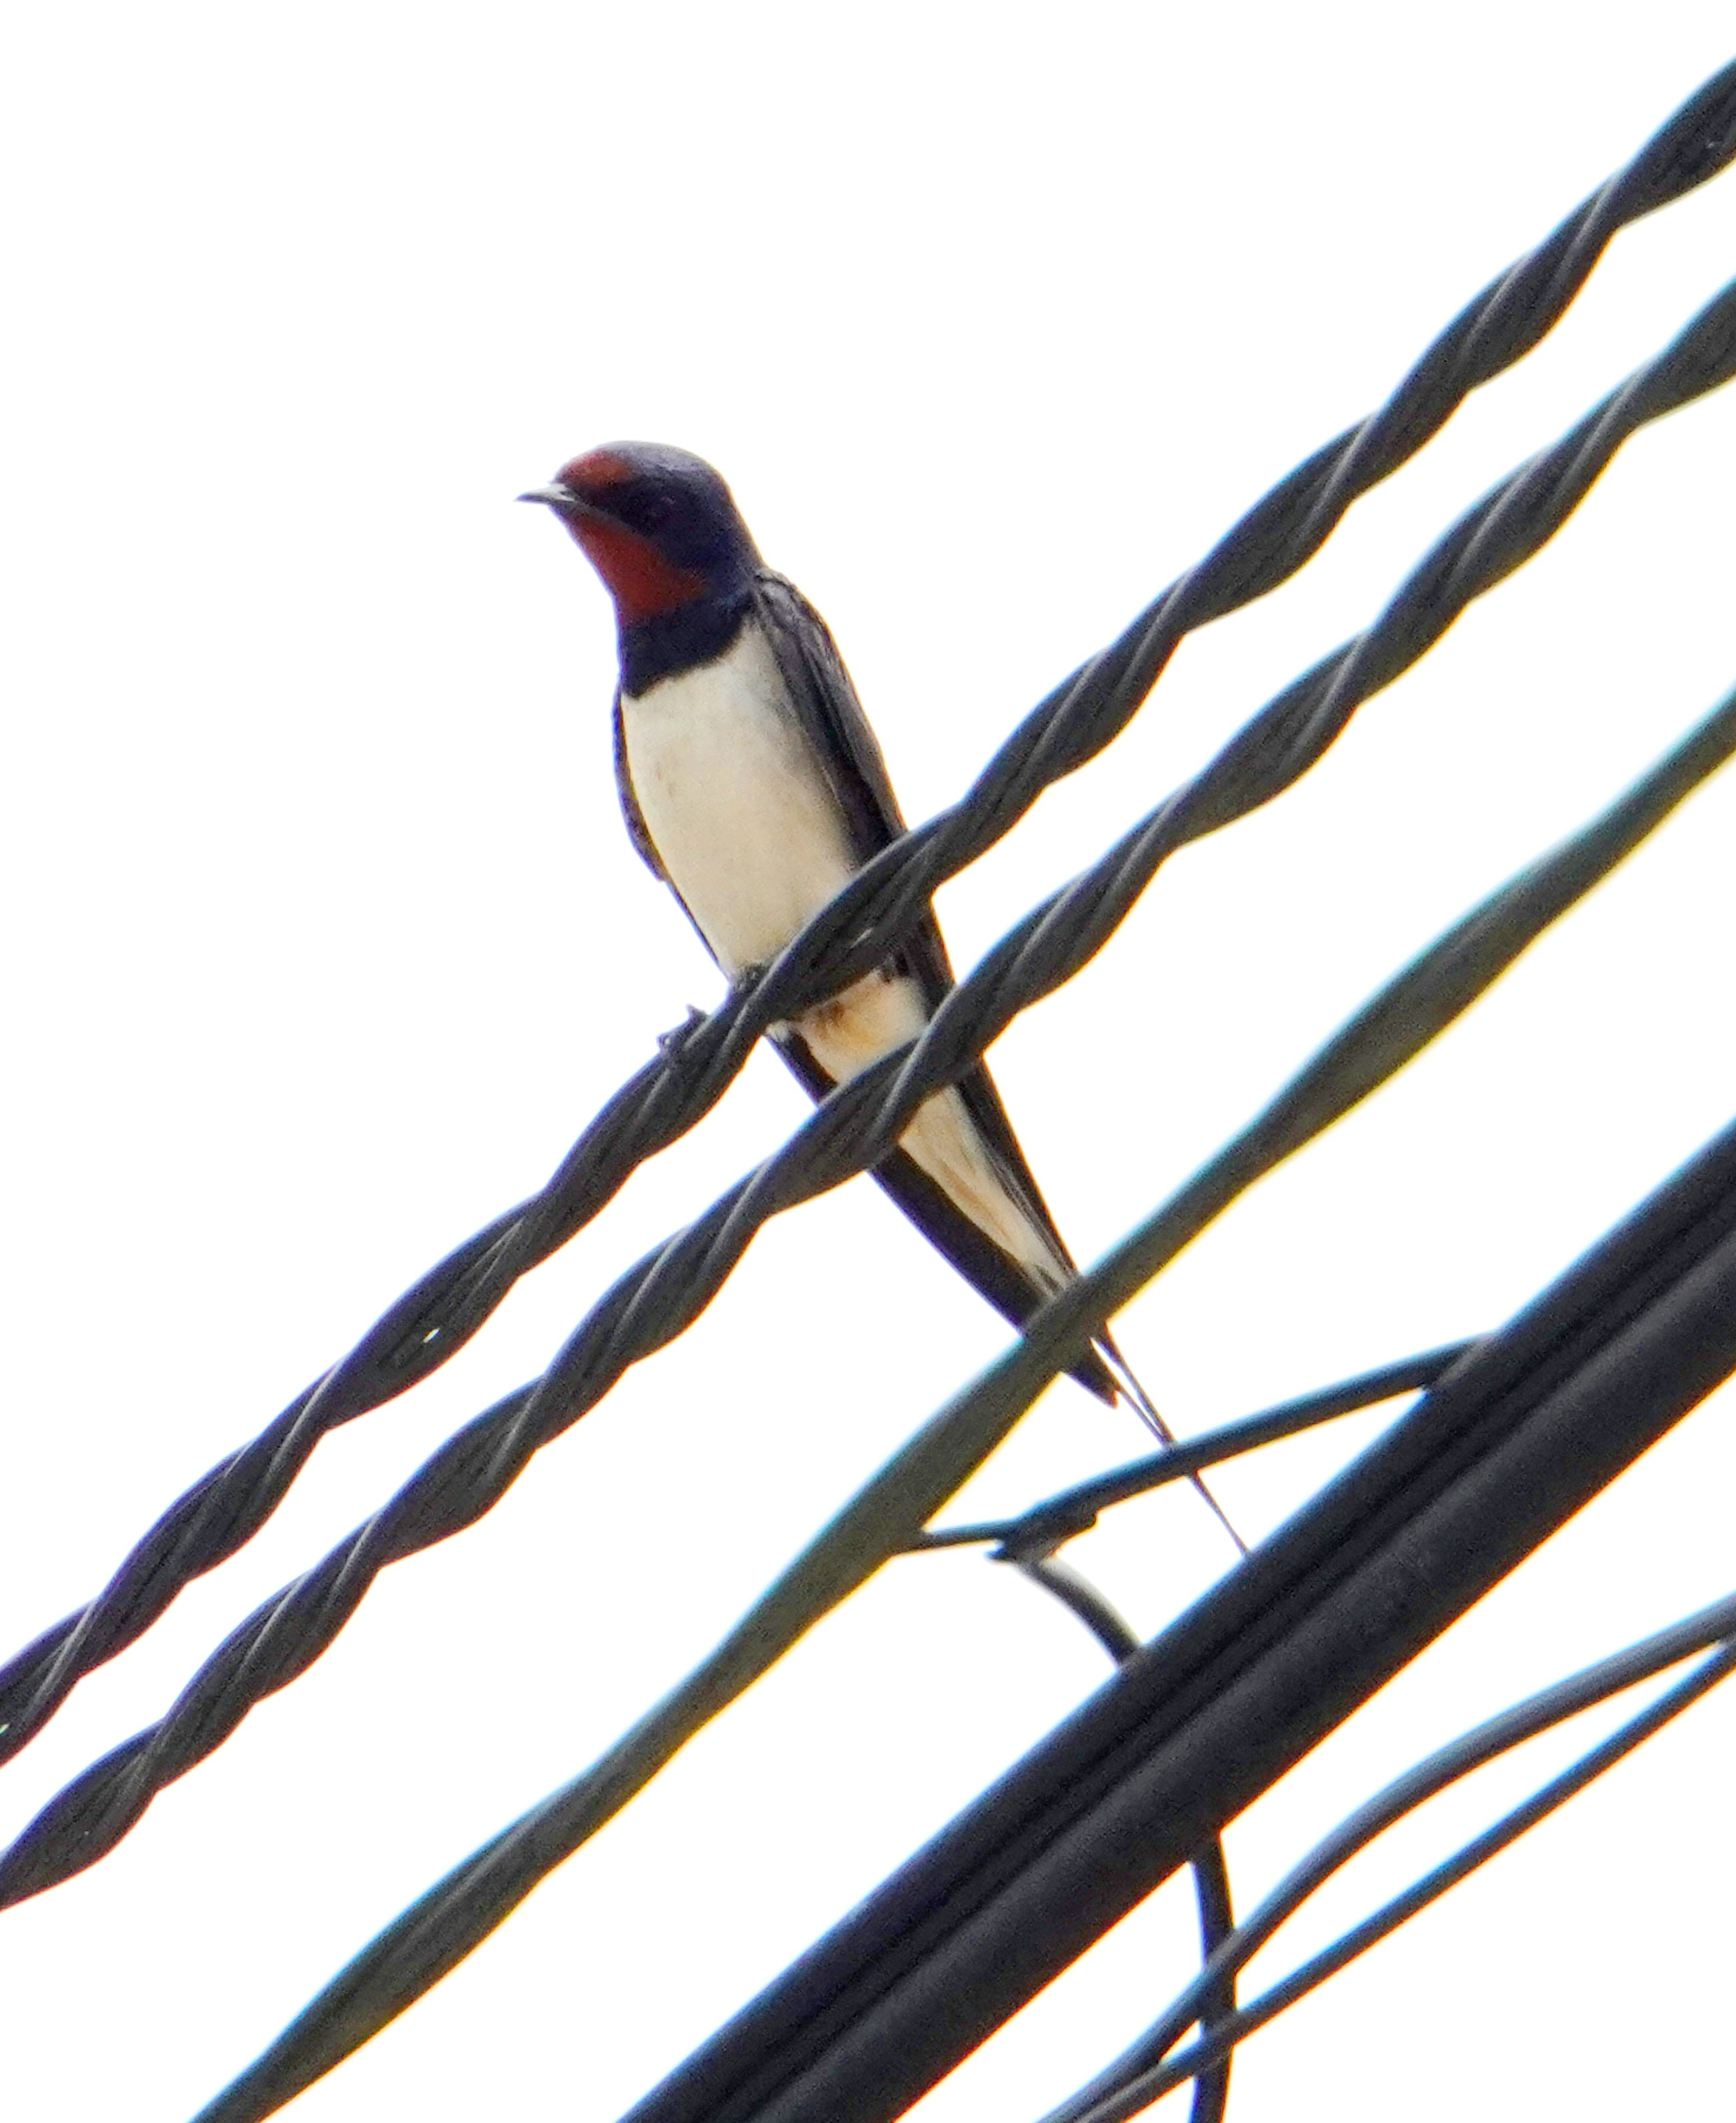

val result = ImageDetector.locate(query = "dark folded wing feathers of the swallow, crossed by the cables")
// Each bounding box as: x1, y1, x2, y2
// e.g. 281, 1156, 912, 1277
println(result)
754, 569, 1114, 1399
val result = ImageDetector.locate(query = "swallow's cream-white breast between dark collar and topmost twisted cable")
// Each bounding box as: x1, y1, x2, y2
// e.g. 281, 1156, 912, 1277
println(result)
622, 624, 858, 974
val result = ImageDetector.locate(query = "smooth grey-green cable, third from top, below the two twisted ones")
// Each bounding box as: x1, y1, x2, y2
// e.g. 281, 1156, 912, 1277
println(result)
139, 694, 1736, 2123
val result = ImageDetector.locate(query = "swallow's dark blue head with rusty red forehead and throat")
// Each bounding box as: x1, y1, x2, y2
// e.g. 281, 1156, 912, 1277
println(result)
518, 442, 760, 628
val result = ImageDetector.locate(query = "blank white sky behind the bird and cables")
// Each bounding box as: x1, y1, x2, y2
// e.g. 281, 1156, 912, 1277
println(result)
0, 0, 1736, 2123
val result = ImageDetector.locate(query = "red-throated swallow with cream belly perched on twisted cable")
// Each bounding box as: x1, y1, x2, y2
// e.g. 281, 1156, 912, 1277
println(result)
520, 442, 1222, 1554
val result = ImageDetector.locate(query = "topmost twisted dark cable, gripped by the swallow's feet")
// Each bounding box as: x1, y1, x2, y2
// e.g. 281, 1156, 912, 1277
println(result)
0, 64, 1736, 1760
